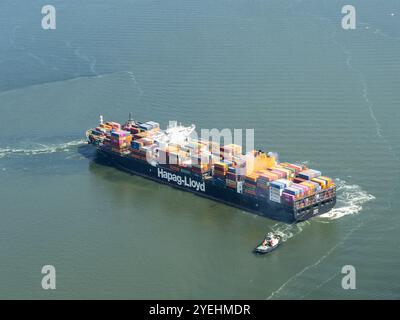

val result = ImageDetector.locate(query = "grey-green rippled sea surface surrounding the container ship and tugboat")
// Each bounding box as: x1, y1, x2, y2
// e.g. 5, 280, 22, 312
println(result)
0, 0, 400, 299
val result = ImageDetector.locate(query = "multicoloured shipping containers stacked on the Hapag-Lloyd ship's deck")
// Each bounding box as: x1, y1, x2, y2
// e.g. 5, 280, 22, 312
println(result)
92, 121, 333, 204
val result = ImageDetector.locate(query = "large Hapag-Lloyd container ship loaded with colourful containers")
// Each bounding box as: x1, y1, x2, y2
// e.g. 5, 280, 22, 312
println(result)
86, 115, 336, 223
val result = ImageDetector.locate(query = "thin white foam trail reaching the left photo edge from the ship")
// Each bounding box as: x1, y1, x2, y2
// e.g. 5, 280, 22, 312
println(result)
0, 139, 85, 159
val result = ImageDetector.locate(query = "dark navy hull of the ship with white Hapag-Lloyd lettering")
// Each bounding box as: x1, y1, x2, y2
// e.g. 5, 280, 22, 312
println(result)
92, 147, 336, 223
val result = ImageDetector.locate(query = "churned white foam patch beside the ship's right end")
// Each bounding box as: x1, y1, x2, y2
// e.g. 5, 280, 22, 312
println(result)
319, 179, 375, 220
